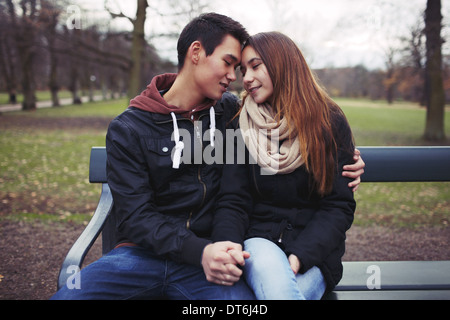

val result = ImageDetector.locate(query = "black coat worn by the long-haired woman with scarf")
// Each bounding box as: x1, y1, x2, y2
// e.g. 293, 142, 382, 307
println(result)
213, 110, 356, 291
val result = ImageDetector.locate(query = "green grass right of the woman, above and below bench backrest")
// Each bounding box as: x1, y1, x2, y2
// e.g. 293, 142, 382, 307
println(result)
335, 99, 450, 227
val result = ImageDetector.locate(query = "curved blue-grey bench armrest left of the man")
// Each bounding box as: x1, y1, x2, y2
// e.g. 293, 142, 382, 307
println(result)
58, 183, 113, 290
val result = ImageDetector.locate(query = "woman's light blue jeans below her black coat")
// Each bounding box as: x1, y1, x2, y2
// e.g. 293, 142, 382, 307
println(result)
244, 238, 326, 300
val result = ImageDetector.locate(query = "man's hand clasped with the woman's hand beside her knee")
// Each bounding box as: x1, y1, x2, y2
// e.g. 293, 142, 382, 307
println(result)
202, 241, 250, 286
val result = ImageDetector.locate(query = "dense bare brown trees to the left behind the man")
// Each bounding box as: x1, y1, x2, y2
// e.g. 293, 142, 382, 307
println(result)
0, 0, 176, 110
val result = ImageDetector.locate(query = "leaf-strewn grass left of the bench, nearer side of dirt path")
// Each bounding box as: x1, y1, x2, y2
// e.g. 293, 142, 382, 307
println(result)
0, 130, 106, 216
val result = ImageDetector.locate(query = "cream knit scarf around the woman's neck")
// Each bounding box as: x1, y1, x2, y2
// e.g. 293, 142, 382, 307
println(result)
239, 96, 304, 175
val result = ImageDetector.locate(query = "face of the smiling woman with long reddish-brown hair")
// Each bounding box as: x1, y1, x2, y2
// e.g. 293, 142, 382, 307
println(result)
241, 46, 273, 103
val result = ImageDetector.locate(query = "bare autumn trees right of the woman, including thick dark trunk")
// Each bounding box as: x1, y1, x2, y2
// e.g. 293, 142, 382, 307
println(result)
317, 0, 450, 141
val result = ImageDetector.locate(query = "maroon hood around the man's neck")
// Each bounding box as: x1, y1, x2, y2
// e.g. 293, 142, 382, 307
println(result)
130, 73, 215, 114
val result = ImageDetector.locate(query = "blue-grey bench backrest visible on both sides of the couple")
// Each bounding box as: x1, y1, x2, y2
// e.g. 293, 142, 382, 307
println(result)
89, 147, 450, 183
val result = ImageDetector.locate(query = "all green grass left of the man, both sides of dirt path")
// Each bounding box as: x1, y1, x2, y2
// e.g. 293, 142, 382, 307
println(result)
0, 99, 127, 221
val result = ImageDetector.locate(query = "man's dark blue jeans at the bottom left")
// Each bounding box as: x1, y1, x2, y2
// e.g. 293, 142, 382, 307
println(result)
52, 247, 254, 300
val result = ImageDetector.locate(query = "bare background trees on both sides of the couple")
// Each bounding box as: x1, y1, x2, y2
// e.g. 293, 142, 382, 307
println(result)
0, 0, 450, 140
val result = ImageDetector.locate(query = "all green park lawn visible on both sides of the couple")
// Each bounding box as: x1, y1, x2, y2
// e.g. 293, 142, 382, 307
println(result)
0, 99, 450, 228
